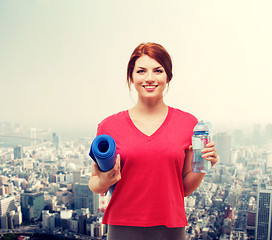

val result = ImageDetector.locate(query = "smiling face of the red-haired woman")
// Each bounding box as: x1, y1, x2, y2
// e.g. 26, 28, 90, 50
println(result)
131, 55, 168, 101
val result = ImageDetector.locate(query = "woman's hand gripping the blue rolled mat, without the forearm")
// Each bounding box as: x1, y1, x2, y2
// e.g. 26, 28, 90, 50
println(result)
92, 154, 121, 192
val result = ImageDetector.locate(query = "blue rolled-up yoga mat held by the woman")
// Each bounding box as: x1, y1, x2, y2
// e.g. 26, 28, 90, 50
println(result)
89, 134, 117, 195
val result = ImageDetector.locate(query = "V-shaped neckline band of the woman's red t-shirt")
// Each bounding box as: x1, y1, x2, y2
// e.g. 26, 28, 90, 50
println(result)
124, 107, 173, 142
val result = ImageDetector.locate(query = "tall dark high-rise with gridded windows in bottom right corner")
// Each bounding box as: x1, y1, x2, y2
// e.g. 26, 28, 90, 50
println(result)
255, 189, 272, 240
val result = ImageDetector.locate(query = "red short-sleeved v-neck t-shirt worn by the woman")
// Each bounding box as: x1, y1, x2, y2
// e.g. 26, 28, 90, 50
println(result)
97, 107, 197, 227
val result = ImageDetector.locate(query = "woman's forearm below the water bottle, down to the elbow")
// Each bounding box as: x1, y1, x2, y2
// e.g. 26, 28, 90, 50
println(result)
183, 172, 205, 197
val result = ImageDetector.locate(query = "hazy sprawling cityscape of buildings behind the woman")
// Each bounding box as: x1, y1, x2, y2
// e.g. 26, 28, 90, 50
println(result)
0, 122, 272, 240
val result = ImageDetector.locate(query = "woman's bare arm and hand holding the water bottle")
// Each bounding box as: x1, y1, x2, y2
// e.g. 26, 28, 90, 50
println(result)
182, 142, 218, 197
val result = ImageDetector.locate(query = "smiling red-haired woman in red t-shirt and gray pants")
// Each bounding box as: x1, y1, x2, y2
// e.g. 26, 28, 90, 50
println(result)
89, 43, 217, 240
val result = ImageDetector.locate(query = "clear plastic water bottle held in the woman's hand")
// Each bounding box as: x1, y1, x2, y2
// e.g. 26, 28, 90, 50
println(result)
192, 121, 211, 173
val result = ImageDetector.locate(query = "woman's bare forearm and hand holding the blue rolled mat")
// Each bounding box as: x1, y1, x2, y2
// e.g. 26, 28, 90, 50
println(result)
89, 154, 121, 194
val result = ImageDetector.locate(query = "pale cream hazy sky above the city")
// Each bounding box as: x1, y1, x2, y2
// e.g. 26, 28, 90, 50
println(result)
0, 0, 272, 138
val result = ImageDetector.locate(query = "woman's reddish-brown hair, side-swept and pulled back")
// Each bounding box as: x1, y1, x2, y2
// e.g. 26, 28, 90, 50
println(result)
127, 43, 173, 87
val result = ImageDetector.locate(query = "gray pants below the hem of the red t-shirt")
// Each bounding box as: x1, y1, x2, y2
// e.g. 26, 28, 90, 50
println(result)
107, 225, 186, 240
